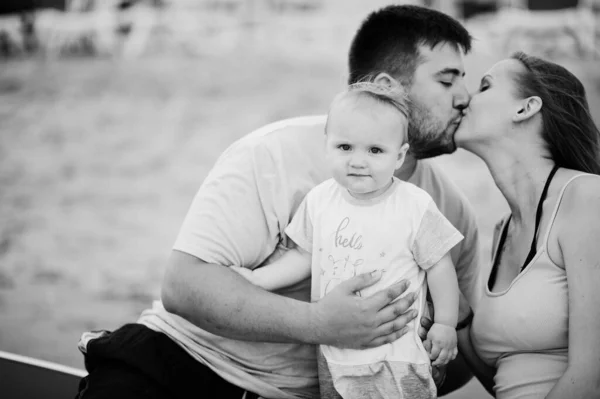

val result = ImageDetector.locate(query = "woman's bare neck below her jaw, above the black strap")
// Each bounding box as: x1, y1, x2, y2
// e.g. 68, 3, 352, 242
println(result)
480, 148, 554, 224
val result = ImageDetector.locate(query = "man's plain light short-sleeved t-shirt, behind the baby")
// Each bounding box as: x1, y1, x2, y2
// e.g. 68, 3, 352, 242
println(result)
139, 116, 479, 398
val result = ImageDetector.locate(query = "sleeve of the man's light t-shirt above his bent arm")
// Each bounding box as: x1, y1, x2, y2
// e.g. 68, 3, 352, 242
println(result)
173, 138, 279, 267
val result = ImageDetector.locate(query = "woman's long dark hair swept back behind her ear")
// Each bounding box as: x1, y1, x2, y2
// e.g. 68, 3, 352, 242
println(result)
511, 52, 600, 174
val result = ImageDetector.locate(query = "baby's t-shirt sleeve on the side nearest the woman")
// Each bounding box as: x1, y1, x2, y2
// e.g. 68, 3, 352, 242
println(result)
412, 200, 463, 270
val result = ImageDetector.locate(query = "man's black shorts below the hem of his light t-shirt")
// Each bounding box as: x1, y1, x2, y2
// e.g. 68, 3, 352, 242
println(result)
75, 324, 257, 399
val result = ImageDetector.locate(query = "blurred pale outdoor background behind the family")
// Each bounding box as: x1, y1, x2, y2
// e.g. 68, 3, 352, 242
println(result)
0, 0, 600, 397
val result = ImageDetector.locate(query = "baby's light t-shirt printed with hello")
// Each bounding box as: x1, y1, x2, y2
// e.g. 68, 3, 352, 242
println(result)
285, 178, 463, 364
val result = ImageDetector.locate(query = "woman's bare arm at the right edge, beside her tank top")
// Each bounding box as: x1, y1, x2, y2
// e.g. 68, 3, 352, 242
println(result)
546, 180, 600, 399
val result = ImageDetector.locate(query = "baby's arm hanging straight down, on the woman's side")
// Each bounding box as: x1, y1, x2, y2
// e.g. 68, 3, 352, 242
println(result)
427, 253, 459, 366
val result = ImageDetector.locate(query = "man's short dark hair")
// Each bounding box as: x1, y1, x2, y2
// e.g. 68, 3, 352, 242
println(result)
348, 5, 471, 84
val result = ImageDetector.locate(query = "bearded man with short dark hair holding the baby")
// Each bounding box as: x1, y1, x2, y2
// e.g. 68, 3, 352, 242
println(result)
80, 6, 478, 398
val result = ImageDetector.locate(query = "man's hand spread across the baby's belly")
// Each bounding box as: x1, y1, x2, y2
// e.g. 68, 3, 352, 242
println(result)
313, 271, 417, 349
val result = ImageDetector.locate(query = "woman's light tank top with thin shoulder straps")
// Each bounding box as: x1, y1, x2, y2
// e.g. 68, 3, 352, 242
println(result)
471, 174, 585, 399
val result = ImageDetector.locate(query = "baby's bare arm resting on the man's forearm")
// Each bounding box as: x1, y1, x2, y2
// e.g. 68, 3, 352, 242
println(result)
231, 247, 311, 291
